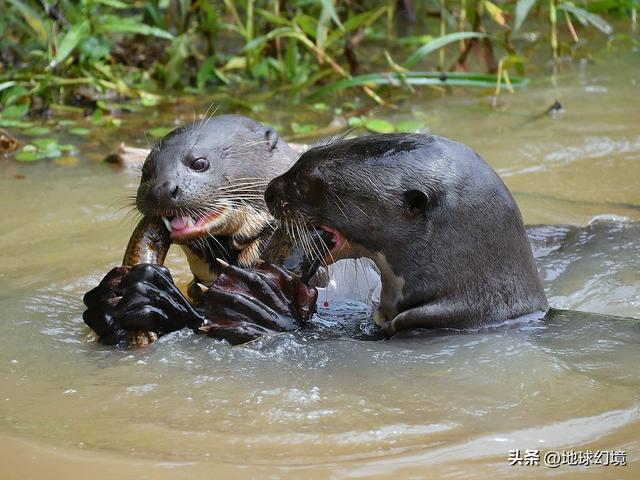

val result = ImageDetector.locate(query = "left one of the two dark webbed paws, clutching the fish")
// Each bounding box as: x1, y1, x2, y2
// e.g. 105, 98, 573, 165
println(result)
82, 264, 204, 345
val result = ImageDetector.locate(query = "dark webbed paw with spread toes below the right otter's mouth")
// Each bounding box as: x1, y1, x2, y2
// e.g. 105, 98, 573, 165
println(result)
200, 261, 318, 344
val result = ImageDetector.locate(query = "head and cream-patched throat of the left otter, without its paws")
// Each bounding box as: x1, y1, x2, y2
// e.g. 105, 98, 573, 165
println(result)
136, 115, 298, 285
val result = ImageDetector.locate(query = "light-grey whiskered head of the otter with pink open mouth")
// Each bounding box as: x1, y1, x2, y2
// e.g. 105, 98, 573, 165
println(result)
136, 115, 295, 243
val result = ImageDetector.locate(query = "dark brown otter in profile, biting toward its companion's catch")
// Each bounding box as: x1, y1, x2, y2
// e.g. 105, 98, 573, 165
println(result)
265, 135, 548, 334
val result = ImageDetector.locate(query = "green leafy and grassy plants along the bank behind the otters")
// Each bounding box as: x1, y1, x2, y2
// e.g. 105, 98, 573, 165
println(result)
0, 0, 638, 117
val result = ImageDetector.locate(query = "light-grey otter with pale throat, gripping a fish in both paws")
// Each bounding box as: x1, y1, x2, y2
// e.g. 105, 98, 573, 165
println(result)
83, 115, 318, 344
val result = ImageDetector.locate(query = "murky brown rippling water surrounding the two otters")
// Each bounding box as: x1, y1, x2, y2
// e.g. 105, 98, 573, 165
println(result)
0, 52, 640, 479
